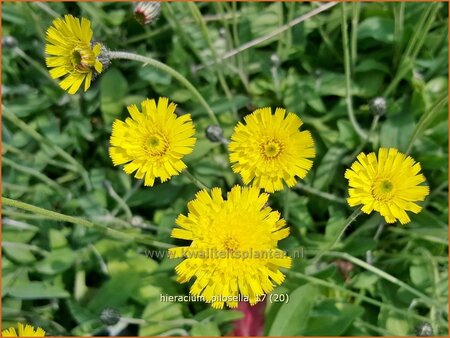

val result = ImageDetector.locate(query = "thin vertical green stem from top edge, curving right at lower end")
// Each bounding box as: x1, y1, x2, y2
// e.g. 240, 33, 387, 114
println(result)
341, 2, 367, 139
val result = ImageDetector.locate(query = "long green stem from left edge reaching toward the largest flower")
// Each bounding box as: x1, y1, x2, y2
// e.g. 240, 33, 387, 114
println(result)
2, 196, 172, 249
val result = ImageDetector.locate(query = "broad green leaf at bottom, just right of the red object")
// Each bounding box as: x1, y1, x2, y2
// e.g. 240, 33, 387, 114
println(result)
268, 284, 318, 336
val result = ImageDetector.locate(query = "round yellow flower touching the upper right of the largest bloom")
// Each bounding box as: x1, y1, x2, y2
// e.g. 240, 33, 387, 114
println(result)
229, 108, 315, 192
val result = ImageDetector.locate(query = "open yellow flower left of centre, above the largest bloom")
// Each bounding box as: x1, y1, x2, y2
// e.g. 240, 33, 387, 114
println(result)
109, 97, 196, 186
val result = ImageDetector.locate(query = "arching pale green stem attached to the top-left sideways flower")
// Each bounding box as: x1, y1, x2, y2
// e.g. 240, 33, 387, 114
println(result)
108, 51, 220, 125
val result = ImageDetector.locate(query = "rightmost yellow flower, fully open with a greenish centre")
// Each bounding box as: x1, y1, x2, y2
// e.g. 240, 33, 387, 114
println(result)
345, 148, 429, 224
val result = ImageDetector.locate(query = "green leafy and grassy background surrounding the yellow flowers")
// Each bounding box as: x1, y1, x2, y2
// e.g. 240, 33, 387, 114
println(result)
2, 2, 448, 336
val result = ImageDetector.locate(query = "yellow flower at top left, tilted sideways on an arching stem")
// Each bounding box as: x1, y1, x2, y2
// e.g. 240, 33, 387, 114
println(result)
45, 15, 103, 94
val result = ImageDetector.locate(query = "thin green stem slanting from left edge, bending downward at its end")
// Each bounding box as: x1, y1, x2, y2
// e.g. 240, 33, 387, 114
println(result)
2, 105, 92, 191
